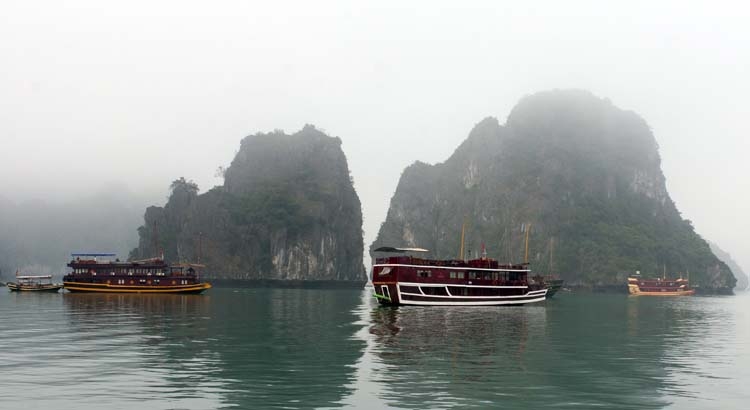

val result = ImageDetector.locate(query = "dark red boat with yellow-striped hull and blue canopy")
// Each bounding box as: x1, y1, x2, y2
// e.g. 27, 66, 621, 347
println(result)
63, 253, 211, 293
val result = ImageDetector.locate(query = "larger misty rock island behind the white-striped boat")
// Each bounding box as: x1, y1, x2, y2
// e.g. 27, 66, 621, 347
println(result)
371, 90, 734, 291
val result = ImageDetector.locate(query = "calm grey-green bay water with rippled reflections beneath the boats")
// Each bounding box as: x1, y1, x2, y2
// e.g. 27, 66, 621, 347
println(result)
0, 289, 750, 410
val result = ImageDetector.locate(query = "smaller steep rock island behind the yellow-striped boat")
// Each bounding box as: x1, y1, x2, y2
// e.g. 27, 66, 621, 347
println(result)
131, 125, 366, 282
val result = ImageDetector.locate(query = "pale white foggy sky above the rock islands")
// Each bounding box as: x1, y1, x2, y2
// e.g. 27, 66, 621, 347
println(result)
0, 0, 750, 271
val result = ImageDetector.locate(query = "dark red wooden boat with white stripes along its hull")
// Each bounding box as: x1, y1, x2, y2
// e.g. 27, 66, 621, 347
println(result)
372, 247, 547, 306
